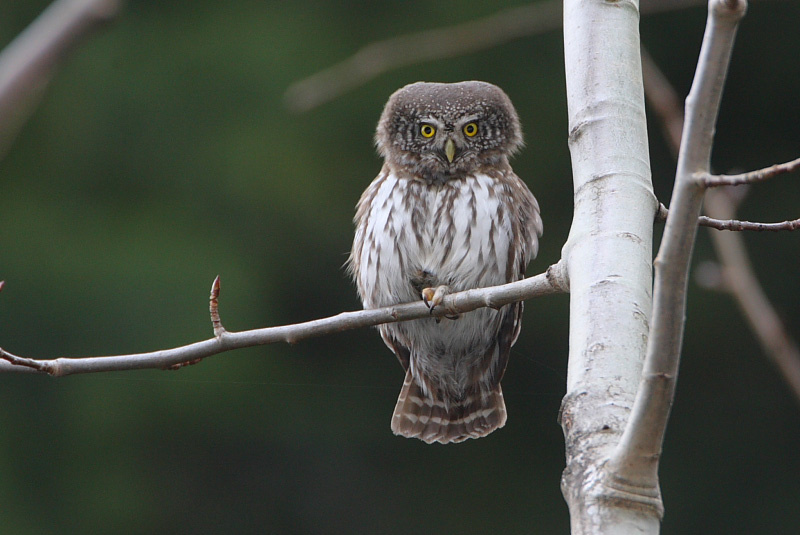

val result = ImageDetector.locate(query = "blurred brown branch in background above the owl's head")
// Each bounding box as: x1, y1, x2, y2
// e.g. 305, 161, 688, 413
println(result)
285, 0, 744, 111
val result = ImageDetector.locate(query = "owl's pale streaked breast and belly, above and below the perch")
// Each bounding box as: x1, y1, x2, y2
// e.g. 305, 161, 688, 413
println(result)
358, 174, 513, 391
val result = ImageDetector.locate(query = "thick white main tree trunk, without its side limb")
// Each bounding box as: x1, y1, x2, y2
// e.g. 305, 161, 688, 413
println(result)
561, 0, 661, 534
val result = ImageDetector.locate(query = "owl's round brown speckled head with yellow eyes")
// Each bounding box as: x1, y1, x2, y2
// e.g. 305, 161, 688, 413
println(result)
375, 82, 522, 182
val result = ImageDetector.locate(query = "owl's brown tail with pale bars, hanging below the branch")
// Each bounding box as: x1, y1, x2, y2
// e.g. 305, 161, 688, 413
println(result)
392, 369, 506, 444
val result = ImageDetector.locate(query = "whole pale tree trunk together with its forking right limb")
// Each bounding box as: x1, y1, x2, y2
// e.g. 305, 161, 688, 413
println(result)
562, 0, 752, 534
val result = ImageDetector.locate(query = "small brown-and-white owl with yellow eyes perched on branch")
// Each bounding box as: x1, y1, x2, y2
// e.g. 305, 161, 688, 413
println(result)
348, 81, 542, 444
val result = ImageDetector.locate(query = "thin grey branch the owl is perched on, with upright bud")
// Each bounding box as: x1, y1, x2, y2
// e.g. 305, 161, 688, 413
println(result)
0, 262, 568, 376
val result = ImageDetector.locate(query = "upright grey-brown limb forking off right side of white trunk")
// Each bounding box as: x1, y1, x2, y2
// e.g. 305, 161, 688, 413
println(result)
609, 0, 747, 488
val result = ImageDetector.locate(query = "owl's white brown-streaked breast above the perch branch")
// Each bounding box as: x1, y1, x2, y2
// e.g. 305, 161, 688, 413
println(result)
358, 172, 513, 308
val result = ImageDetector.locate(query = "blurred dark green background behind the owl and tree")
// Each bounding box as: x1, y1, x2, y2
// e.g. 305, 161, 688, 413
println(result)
0, 0, 800, 534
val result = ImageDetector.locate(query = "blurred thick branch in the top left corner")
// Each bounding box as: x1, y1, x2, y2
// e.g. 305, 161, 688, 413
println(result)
0, 0, 122, 157
